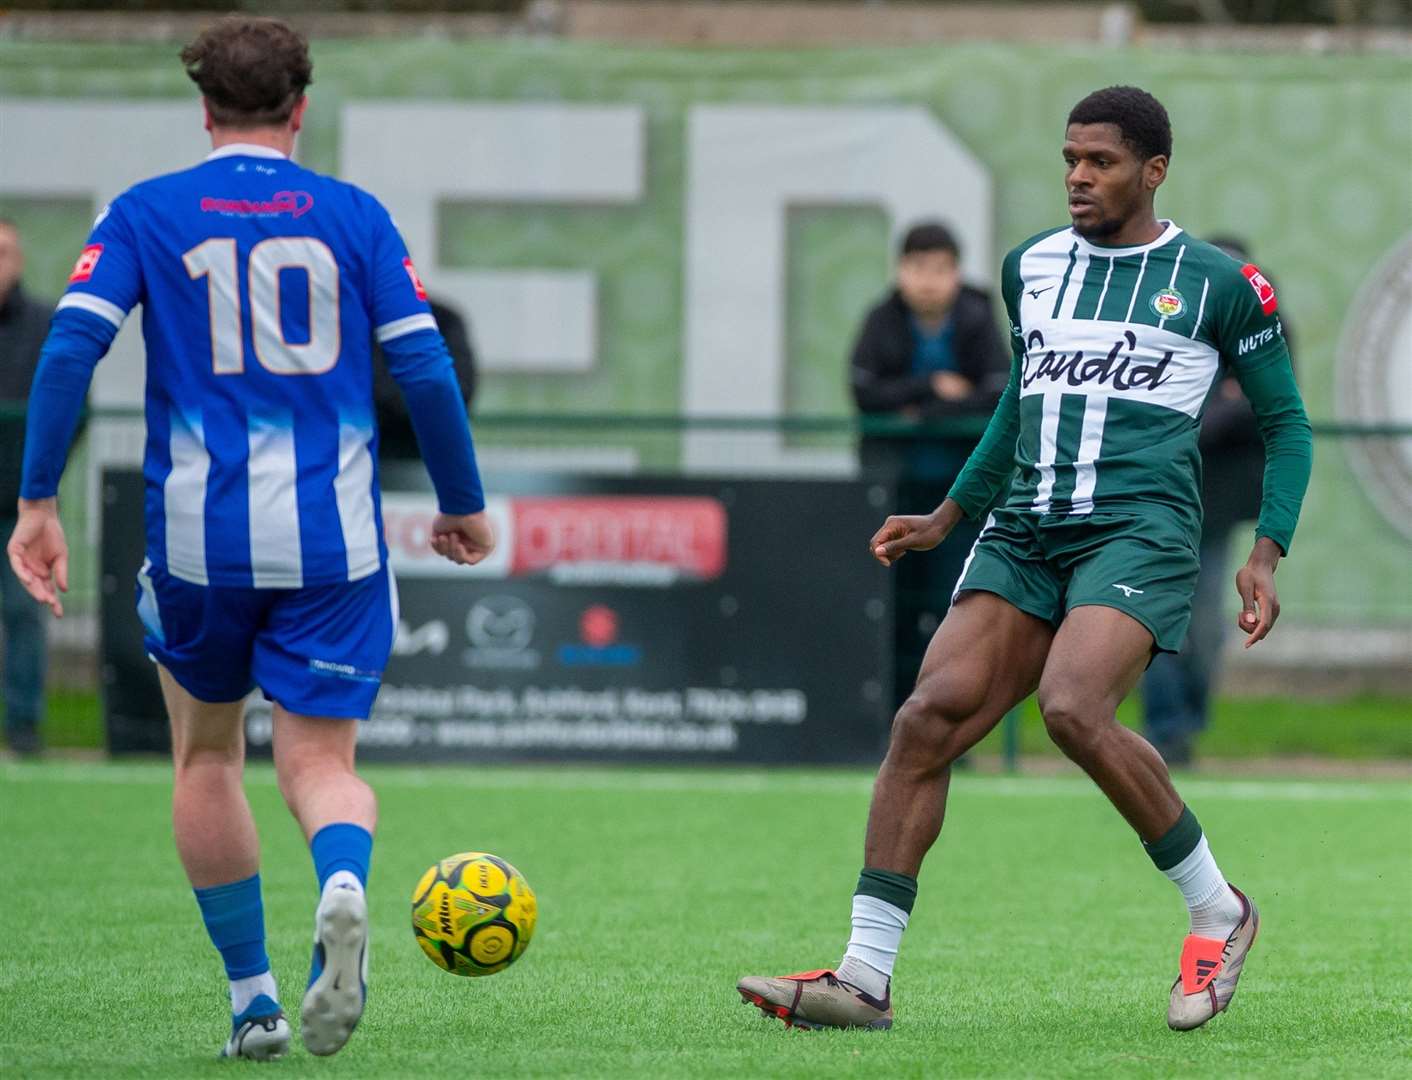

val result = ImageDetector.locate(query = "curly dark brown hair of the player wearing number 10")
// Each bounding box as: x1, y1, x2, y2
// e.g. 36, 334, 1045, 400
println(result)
181, 16, 313, 128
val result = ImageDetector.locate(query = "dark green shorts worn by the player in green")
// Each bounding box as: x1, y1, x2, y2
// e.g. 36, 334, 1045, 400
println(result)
953, 508, 1200, 652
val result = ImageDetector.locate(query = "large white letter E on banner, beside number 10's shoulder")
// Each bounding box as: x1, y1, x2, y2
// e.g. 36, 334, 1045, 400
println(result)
342, 102, 644, 371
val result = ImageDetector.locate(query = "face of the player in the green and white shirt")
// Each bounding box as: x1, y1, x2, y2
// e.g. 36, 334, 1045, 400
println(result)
1063, 124, 1166, 240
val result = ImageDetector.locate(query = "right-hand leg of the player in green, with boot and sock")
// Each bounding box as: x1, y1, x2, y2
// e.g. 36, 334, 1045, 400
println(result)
1039, 601, 1258, 1028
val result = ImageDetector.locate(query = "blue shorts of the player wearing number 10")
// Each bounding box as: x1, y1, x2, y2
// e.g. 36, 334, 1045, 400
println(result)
137, 563, 397, 720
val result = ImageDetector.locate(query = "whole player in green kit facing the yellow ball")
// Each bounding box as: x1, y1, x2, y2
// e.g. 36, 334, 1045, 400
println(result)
737, 86, 1312, 1031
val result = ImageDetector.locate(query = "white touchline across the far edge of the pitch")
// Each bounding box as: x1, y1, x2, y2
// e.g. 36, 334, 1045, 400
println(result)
0, 762, 1412, 802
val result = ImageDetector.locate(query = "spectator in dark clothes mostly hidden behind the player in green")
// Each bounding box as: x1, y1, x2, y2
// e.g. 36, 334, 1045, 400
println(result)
1142, 237, 1295, 765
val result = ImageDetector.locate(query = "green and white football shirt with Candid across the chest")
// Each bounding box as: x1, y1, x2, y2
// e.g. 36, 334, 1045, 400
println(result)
952, 222, 1302, 546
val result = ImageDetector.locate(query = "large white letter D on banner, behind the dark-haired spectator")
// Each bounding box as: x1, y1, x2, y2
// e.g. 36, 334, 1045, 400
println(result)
682, 106, 998, 472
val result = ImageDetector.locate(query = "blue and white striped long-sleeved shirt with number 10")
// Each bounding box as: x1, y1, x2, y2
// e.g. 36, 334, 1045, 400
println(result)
23, 144, 484, 589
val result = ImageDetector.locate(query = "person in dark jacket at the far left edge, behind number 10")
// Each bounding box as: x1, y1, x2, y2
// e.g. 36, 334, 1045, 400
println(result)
0, 217, 54, 755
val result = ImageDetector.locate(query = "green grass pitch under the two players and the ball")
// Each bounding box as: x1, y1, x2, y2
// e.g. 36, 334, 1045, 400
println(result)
0, 764, 1412, 1080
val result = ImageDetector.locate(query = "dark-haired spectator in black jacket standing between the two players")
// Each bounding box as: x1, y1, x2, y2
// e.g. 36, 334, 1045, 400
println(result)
851, 222, 1010, 708
